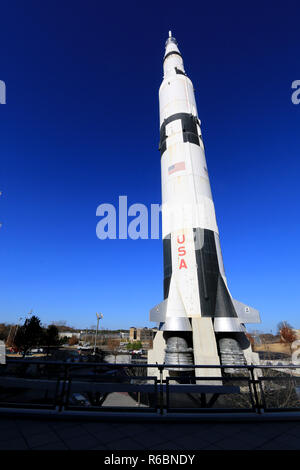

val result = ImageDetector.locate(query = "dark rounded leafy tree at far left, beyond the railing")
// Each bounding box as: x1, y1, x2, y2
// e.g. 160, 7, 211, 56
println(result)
14, 315, 43, 357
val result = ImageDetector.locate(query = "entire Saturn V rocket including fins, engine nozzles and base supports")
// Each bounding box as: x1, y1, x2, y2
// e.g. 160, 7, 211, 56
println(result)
148, 32, 260, 376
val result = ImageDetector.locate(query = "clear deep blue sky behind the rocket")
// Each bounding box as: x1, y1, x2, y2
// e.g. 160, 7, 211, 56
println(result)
0, 0, 300, 332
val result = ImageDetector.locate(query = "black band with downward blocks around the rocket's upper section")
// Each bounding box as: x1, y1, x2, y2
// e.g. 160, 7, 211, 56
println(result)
159, 113, 201, 156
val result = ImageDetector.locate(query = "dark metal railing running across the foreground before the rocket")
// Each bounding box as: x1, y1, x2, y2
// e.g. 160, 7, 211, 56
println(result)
0, 359, 300, 415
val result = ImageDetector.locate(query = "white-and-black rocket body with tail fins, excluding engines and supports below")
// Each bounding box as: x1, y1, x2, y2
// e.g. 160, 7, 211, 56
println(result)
150, 33, 260, 364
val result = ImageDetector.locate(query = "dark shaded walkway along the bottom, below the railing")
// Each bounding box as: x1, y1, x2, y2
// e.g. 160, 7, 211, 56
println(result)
0, 416, 300, 451
